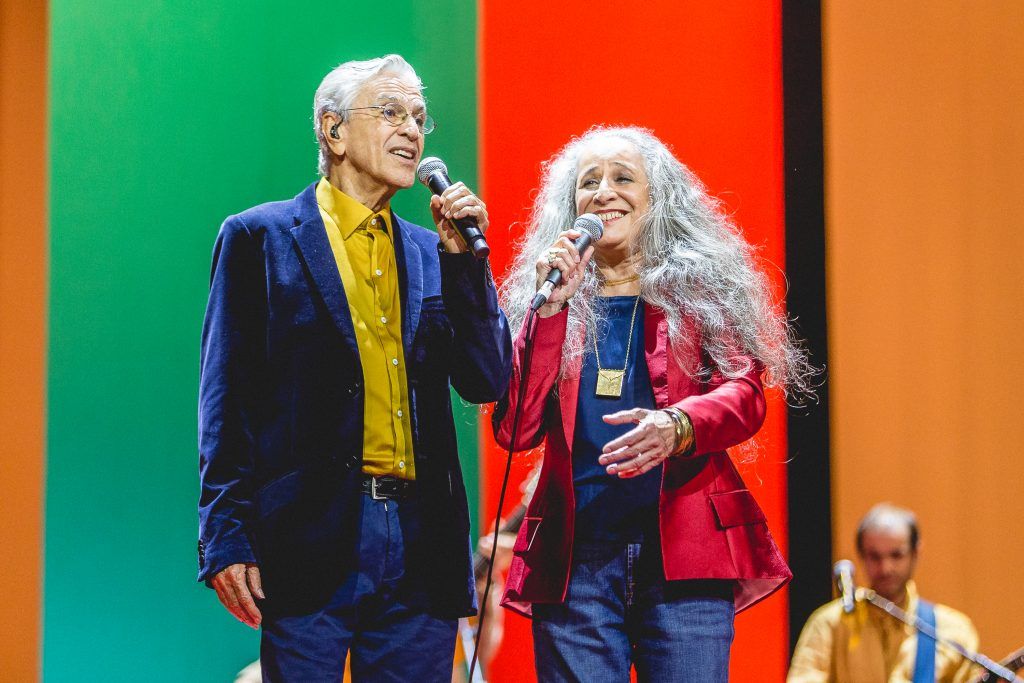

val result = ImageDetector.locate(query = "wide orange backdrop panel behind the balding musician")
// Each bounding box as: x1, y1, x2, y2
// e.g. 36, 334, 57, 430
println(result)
822, 0, 1024, 658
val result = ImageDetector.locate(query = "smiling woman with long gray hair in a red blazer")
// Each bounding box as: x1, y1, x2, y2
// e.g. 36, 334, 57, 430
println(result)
495, 128, 812, 681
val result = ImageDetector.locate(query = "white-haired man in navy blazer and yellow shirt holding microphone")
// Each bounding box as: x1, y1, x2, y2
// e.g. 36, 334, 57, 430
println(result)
199, 55, 511, 681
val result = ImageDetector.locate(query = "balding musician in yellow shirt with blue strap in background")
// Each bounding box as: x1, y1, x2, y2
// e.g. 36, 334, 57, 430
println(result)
786, 503, 978, 683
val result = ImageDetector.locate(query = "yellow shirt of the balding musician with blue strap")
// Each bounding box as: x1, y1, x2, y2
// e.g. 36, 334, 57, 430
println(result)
785, 582, 978, 683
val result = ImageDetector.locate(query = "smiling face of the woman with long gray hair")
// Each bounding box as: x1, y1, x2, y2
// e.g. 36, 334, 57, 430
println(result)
575, 137, 650, 253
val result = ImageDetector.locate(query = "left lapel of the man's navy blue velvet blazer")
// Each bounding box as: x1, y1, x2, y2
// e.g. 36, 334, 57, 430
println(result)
292, 184, 358, 350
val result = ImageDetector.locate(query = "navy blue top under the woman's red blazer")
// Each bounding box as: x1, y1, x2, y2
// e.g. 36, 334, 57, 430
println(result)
572, 296, 662, 543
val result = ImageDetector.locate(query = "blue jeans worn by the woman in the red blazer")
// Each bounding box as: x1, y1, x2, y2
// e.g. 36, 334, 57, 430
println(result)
532, 541, 735, 683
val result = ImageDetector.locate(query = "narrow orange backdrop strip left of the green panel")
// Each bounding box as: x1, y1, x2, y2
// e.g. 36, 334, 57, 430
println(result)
0, 2, 47, 681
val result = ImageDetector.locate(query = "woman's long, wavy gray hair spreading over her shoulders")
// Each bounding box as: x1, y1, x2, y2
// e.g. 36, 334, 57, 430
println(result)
500, 126, 816, 400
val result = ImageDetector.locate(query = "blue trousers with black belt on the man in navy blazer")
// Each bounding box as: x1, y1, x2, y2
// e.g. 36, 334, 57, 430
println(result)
260, 496, 458, 683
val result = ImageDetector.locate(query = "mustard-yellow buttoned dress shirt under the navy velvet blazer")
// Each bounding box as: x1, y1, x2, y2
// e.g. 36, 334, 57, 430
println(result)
316, 178, 416, 479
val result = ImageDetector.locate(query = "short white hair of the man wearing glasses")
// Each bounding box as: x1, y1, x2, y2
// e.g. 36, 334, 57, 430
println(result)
313, 54, 423, 176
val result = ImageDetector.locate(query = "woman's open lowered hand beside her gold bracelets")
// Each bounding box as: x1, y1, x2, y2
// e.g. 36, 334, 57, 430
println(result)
597, 408, 688, 479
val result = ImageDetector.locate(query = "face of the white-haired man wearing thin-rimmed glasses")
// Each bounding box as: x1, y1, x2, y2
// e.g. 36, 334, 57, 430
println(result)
340, 74, 427, 194
